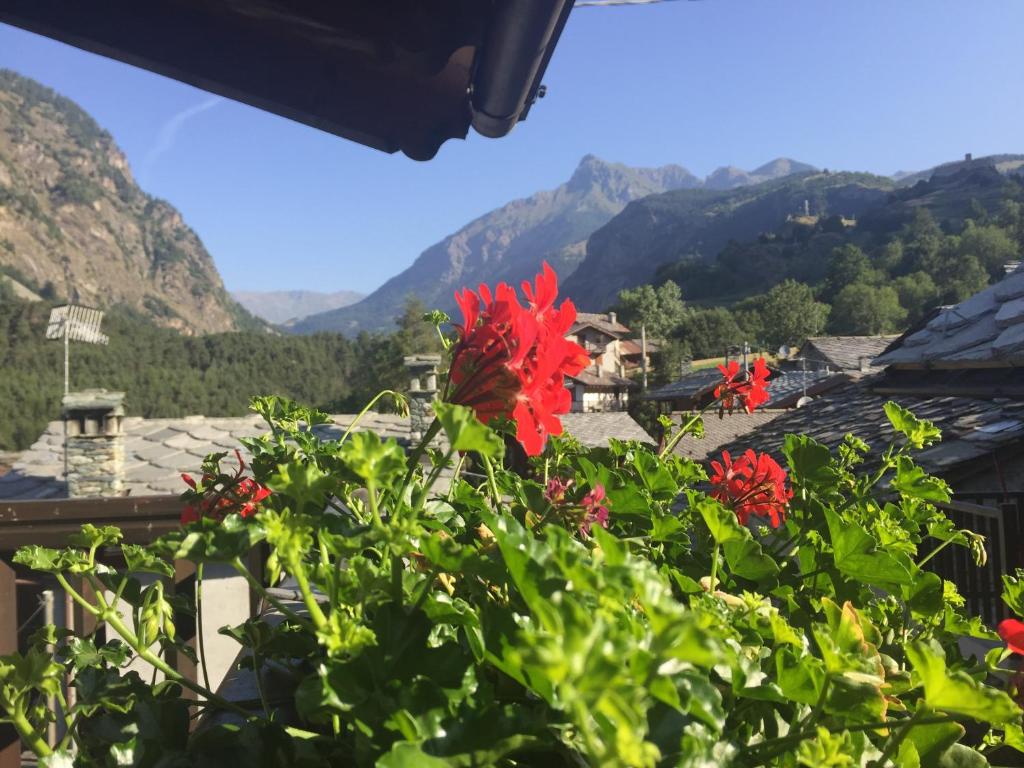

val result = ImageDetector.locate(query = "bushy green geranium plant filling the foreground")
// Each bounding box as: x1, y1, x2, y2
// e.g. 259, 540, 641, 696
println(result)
0, 268, 1024, 768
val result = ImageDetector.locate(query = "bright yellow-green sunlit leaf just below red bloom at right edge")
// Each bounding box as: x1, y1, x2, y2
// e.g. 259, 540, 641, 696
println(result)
906, 641, 1021, 725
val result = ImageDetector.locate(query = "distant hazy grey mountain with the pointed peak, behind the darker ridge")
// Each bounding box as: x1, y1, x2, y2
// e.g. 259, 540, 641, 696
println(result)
291, 155, 812, 334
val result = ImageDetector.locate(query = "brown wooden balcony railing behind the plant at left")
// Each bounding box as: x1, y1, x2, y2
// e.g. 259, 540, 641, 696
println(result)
0, 496, 188, 768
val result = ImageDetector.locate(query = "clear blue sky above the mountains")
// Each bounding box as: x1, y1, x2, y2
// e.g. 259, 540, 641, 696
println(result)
0, 0, 1024, 291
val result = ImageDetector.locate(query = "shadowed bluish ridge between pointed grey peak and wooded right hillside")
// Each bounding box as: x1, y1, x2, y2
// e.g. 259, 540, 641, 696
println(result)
563, 172, 894, 311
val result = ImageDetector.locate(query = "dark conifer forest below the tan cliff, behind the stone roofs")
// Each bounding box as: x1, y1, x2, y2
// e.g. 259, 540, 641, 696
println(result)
0, 292, 437, 452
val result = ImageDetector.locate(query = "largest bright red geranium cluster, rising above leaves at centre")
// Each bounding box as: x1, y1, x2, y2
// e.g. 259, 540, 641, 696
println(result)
447, 262, 590, 456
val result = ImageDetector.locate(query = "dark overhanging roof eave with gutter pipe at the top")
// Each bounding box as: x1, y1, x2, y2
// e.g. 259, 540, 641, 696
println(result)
0, 0, 572, 160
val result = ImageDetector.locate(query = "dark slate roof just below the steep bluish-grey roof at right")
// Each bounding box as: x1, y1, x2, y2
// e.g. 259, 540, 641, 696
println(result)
712, 377, 1024, 481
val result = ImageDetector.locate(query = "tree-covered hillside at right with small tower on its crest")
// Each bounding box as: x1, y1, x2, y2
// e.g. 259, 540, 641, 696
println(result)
618, 167, 1024, 371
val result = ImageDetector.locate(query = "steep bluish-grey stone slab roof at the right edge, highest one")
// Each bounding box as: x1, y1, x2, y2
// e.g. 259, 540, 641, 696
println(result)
876, 266, 1024, 368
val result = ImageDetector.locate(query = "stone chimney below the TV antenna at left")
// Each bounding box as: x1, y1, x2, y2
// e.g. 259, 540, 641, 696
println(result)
62, 389, 125, 499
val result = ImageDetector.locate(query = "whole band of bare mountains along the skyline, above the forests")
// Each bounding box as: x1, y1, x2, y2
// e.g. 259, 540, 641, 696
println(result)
0, 70, 1024, 335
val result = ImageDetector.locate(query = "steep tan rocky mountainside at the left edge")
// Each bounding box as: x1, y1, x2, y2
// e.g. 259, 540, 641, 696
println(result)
0, 70, 256, 334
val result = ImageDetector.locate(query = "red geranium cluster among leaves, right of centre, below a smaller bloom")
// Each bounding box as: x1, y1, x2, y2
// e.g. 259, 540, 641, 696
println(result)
711, 450, 793, 528
